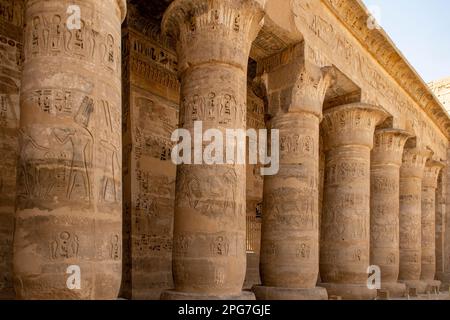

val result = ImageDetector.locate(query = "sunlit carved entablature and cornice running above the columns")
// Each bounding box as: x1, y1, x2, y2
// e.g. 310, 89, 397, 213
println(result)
293, 0, 448, 157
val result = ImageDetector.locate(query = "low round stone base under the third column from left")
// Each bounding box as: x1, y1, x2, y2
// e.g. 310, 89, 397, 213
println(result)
252, 286, 328, 300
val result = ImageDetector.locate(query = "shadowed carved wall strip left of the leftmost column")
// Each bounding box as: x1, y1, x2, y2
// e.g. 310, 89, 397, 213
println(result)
0, 0, 23, 299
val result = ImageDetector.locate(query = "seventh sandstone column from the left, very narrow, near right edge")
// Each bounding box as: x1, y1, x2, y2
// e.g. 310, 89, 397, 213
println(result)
420, 160, 444, 287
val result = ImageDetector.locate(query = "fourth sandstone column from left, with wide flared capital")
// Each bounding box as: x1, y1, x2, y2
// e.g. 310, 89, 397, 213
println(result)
320, 103, 388, 299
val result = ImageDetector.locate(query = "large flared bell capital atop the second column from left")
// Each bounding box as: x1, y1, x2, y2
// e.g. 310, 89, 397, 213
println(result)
162, 0, 264, 72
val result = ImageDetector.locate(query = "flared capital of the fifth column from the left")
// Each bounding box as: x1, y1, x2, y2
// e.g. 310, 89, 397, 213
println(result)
372, 129, 412, 166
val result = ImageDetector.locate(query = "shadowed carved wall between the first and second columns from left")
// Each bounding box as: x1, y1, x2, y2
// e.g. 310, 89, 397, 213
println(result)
122, 7, 179, 299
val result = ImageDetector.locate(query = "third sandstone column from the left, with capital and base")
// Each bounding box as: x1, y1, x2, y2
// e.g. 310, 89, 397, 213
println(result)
253, 46, 332, 300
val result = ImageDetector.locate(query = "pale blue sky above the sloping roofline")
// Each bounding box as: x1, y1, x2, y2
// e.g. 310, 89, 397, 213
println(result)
363, 0, 450, 82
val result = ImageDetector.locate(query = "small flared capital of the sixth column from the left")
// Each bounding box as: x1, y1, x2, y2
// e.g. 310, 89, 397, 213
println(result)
401, 147, 433, 179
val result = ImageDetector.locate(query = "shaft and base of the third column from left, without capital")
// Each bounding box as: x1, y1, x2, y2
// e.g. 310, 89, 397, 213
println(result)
255, 112, 327, 299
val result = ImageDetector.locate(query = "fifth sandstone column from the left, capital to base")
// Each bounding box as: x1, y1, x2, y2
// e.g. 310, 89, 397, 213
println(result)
370, 129, 410, 297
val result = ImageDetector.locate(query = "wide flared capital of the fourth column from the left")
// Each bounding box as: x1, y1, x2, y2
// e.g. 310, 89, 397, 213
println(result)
322, 102, 389, 150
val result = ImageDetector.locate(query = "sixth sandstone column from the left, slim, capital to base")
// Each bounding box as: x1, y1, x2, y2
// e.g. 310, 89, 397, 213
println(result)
399, 148, 431, 293
